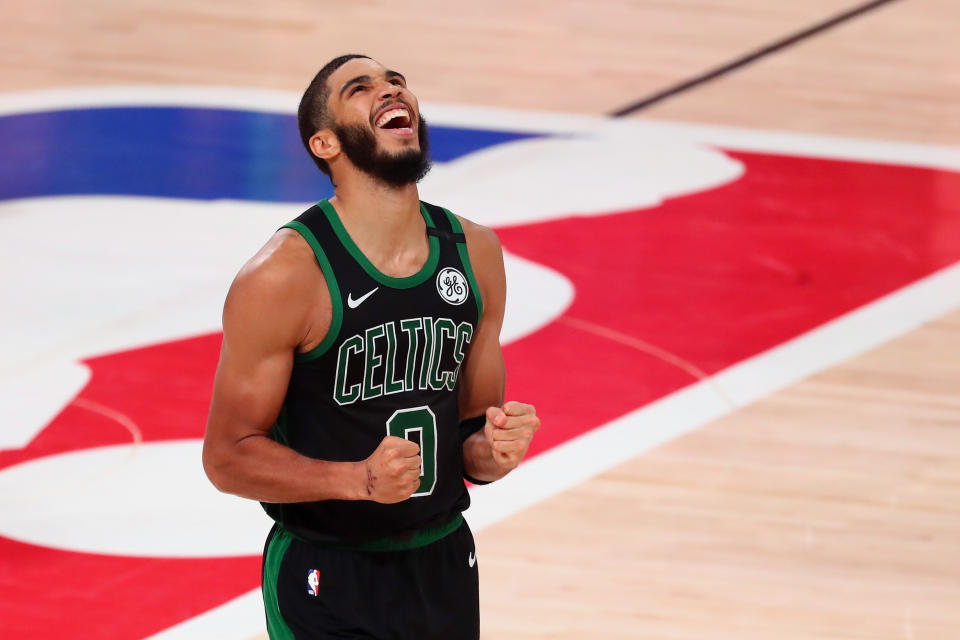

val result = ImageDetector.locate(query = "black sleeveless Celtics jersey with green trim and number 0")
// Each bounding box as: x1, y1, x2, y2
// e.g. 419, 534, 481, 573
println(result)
263, 201, 482, 545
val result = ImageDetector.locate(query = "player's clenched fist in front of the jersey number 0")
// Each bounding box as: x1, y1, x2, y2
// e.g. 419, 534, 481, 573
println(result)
363, 436, 421, 504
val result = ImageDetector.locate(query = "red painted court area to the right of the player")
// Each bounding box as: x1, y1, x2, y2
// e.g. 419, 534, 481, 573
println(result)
499, 152, 960, 451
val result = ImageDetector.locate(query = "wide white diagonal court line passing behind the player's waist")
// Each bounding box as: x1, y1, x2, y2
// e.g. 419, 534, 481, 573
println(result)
148, 264, 960, 640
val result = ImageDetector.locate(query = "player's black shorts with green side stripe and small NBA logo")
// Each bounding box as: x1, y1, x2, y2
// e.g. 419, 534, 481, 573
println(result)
263, 521, 480, 640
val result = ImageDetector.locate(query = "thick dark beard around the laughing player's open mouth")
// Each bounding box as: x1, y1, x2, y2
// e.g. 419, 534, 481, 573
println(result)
331, 114, 432, 187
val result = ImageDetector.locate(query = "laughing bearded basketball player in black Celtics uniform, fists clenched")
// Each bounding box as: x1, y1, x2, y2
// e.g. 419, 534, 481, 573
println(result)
203, 55, 540, 640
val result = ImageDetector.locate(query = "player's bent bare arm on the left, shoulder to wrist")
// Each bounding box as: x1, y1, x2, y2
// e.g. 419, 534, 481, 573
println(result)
203, 232, 365, 502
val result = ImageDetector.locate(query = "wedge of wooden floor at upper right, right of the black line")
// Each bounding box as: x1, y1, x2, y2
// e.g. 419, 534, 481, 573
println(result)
644, 0, 960, 144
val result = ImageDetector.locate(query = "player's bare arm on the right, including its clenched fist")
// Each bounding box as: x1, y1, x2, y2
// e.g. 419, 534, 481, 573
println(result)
459, 219, 540, 482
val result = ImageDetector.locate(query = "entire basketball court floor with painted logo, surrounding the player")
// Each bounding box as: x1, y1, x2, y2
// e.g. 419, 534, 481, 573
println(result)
0, 0, 960, 640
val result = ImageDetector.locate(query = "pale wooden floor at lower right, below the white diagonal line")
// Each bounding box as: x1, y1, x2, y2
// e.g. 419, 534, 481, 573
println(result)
478, 313, 960, 640
